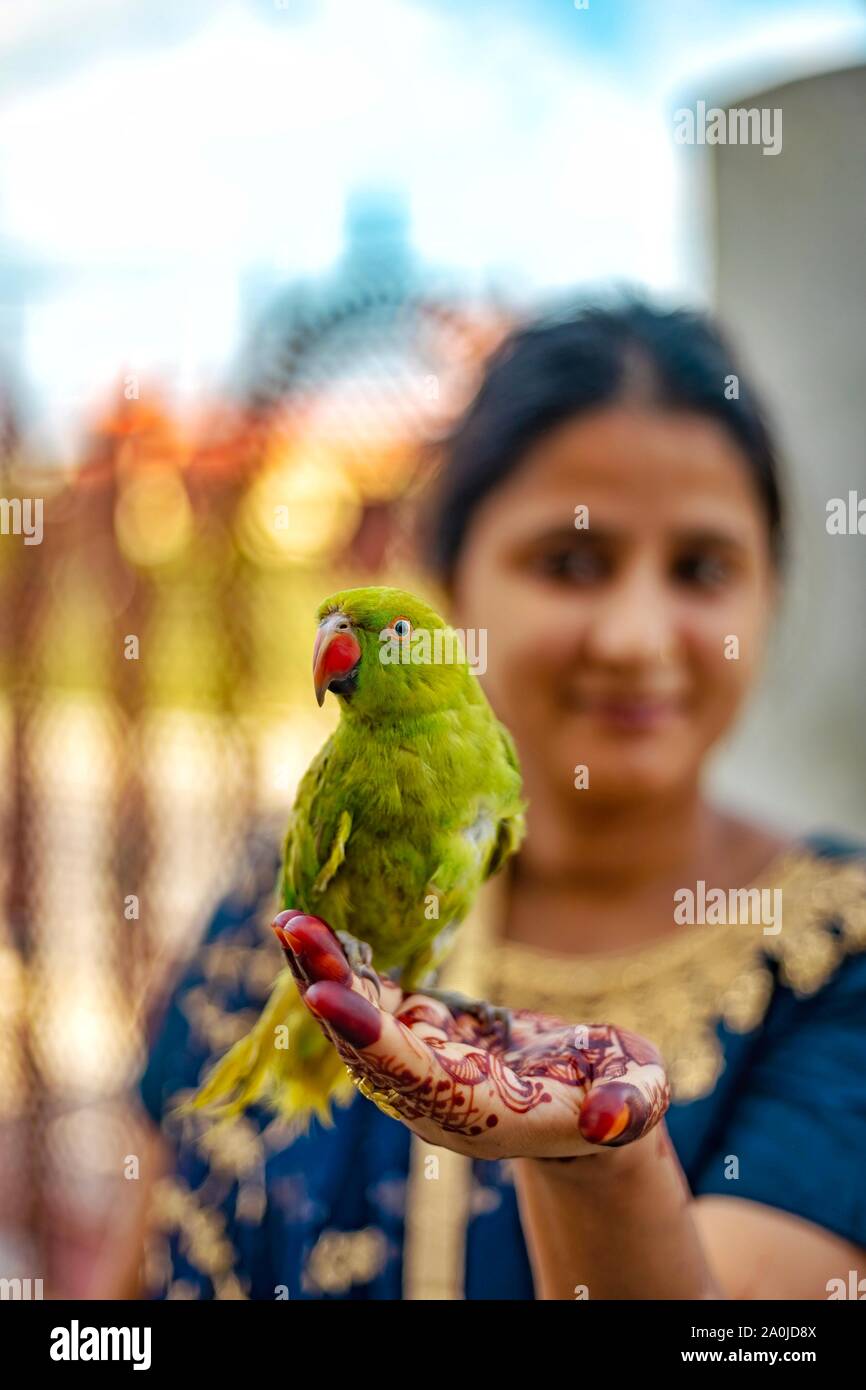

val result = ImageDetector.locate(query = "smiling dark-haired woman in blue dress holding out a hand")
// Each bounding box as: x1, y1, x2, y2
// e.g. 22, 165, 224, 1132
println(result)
128, 303, 866, 1298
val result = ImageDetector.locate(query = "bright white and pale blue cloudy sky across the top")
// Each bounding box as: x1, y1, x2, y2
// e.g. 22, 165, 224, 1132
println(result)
0, 0, 866, 452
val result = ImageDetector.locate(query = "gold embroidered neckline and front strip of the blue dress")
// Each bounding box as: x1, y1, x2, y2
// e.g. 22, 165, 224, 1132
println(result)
403, 847, 866, 1300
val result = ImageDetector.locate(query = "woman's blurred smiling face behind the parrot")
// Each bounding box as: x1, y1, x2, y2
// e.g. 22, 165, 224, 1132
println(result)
453, 406, 774, 805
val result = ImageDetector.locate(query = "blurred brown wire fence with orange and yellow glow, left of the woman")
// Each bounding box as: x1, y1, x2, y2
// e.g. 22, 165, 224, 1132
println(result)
0, 287, 499, 1295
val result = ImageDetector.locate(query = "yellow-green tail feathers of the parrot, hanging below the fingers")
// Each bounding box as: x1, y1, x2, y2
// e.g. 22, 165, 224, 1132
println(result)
179, 970, 354, 1129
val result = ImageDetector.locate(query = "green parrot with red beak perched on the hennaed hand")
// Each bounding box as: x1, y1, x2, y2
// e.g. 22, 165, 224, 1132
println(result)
185, 587, 525, 1127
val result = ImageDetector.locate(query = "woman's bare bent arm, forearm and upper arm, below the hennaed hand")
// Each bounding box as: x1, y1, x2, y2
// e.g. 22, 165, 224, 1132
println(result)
514, 1123, 866, 1300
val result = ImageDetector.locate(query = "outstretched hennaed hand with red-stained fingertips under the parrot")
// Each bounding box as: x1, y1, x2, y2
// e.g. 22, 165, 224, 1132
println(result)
272, 912, 670, 1159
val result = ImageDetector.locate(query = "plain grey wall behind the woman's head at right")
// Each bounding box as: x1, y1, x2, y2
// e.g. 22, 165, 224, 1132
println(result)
700, 67, 866, 837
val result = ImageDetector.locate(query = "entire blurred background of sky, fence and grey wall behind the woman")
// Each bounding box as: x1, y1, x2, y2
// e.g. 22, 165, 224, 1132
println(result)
0, 0, 866, 1297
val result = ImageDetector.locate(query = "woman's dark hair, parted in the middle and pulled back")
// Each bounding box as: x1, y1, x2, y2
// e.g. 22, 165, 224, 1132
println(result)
428, 299, 784, 582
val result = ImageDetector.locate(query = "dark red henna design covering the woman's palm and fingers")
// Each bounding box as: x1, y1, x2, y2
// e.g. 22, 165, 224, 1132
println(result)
271, 919, 670, 1162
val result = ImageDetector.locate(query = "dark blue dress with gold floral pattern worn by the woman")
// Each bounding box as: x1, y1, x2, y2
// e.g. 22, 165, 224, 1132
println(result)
139, 837, 866, 1300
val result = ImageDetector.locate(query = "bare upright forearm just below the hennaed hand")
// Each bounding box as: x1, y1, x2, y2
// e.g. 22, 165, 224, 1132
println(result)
514, 1122, 726, 1298
